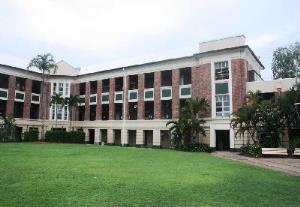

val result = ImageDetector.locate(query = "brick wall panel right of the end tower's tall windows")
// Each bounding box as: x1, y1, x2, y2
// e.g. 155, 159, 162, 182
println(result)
231, 59, 247, 111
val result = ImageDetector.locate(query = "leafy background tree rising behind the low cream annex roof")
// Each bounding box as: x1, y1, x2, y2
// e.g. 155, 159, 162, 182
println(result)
272, 42, 300, 79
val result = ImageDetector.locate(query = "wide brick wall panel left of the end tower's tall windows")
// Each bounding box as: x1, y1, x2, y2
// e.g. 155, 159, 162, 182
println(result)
192, 63, 212, 115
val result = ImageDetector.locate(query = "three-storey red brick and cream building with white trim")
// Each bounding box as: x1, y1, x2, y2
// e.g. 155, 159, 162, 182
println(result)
0, 36, 270, 150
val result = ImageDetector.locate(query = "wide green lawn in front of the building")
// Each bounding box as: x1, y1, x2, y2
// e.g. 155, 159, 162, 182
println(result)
0, 143, 300, 207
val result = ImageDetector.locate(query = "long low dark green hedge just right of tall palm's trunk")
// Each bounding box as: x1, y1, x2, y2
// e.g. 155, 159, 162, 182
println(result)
45, 130, 85, 143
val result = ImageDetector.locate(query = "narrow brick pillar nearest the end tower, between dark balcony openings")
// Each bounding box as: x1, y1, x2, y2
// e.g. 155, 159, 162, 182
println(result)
172, 69, 180, 119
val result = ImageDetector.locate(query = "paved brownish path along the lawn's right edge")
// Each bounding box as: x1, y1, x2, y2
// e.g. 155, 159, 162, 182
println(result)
212, 151, 300, 176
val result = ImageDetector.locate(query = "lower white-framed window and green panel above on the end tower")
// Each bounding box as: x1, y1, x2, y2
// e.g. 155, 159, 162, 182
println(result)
216, 83, 230, 117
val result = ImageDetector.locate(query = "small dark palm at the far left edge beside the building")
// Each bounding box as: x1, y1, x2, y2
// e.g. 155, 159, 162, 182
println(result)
0, 115, 16, 142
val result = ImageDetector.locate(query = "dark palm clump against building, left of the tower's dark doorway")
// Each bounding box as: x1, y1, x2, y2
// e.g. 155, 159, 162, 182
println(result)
167, 98, 209, 147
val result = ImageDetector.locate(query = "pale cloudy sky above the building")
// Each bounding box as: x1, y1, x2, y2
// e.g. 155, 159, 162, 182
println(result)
0, 0, 300, 80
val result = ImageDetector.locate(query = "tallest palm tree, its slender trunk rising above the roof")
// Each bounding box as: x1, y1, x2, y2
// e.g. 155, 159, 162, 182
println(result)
27, 53, 57, 139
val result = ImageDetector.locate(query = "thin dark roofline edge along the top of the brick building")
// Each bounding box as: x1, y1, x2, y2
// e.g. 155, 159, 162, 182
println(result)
0, 45, 265, 78
